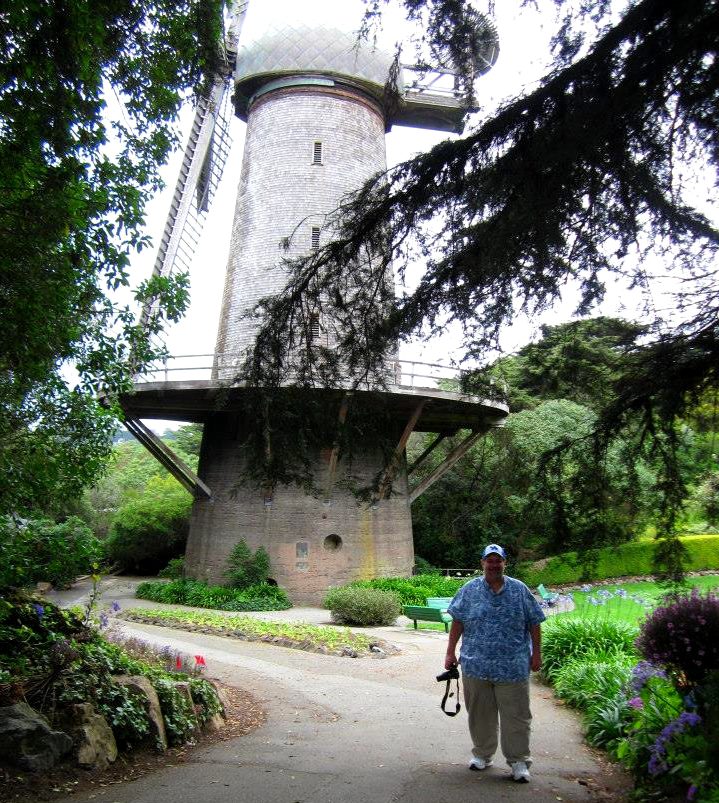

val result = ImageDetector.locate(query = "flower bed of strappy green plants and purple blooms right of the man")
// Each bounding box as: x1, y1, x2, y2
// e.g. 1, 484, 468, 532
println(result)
543, 578, 719, 803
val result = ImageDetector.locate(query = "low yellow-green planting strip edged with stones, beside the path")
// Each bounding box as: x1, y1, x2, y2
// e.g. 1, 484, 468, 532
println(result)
121, 608, 374, 652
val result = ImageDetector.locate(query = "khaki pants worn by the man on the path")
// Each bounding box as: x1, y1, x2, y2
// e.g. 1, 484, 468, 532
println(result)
462, 675, 532, 766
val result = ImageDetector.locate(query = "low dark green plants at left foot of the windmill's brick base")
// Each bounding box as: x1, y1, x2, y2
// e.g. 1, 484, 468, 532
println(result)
135, 580, 292, 611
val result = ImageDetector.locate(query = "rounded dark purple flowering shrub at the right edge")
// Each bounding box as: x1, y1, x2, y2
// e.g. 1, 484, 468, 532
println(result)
637, 589, 719, 685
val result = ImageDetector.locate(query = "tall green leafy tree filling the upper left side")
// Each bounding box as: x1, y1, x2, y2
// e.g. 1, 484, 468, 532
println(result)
0, 0, 222, 513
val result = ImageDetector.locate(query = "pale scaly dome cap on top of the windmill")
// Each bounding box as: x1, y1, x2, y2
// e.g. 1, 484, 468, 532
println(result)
235, 25, 400, 113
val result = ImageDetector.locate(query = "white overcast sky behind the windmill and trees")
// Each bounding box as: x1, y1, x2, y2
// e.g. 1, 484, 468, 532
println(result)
133, 0, 636, 431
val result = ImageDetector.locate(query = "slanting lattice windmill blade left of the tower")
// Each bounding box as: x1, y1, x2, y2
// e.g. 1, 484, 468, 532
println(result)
140, 0, 249, 329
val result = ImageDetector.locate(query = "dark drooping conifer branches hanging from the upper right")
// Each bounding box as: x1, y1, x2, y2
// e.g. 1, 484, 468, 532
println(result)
240, 0, 719, 579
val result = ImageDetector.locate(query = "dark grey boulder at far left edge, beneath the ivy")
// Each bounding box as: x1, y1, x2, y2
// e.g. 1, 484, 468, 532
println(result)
0, 703, 72, 772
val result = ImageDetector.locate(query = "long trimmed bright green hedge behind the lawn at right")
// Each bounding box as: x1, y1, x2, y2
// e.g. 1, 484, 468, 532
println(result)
521, 535, 719, 587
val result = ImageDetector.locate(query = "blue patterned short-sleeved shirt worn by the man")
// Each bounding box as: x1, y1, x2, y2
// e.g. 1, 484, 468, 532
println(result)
447, 577, 546, 682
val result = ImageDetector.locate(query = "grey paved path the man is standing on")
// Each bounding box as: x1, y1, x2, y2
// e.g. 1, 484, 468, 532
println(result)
47, 578, 626, 803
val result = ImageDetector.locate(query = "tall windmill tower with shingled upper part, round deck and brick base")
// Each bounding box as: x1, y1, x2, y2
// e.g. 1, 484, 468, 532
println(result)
125, 3, 506, 600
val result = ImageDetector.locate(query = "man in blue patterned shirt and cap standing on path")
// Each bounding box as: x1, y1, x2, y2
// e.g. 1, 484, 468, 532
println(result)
444, 544, 545, 783
